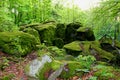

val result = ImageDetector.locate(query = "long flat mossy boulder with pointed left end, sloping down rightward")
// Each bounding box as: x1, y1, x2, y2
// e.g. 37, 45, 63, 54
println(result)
64, 41, 116, 61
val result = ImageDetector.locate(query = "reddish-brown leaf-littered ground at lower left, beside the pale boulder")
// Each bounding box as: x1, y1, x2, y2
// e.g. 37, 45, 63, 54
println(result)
0, 52, 37, 80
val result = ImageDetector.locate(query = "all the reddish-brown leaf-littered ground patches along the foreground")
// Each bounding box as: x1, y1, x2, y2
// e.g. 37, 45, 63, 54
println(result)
0, 52, 96, 80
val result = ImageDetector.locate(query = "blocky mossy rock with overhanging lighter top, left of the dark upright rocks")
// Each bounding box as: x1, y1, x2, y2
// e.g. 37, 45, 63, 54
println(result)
35, 24, 56, 46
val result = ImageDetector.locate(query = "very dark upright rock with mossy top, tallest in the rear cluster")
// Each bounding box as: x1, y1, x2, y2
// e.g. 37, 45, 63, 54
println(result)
65, 23, 81, 43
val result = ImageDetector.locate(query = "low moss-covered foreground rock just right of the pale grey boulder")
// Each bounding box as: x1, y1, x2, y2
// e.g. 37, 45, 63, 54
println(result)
37, 60, 83, 80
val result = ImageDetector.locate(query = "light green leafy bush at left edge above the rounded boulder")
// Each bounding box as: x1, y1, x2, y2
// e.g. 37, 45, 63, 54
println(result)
0, 1, 19, 32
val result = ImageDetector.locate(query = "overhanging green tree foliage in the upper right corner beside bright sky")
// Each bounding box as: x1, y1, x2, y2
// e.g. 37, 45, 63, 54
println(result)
86, 0, 120, 39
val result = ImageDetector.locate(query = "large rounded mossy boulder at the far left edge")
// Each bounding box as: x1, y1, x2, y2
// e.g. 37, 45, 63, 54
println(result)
0, 32, 37, 56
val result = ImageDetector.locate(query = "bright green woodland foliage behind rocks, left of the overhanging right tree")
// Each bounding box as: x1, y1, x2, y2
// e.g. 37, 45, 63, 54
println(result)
0, 0, 85, 28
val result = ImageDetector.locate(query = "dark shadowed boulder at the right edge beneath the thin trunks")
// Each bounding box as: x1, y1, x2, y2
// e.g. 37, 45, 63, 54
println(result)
99, 36, 120, 65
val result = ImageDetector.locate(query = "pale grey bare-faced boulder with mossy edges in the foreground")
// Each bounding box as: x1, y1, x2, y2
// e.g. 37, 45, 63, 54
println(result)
25, 55, 52, 80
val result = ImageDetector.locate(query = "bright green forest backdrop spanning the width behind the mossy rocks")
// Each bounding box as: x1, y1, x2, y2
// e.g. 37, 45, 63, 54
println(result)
0, 0, 120, 40
